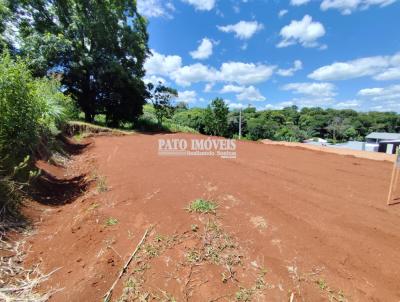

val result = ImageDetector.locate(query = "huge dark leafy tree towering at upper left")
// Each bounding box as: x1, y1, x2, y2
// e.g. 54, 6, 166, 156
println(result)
10, 0, 149, 126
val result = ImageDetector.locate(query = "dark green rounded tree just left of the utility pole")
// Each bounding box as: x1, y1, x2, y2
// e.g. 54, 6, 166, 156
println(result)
204, 98, 229, 136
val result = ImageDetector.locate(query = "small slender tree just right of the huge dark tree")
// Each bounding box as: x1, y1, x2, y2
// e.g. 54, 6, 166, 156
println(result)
147, 82, 178, 127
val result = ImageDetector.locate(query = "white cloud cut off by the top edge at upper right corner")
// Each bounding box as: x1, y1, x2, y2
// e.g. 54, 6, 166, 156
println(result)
321, 0, 397, 15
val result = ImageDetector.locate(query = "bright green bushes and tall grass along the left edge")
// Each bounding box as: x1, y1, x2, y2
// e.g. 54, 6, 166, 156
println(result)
0, 52, 73, 222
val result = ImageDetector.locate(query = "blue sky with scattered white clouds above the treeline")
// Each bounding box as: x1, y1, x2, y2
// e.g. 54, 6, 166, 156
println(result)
138, 0, 400, 112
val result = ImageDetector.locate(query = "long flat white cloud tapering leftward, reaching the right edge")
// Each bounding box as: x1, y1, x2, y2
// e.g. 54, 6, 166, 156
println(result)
308, 53, 400, 81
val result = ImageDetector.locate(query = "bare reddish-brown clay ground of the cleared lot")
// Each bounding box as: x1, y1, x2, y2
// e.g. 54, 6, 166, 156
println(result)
21, 134, 400, 301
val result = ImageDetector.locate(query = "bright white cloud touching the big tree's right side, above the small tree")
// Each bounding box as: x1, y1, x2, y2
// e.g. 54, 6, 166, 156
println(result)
144, 50, 182, 76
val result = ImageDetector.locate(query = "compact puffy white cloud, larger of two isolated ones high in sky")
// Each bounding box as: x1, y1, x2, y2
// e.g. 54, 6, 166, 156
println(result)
277, 15, 325, 47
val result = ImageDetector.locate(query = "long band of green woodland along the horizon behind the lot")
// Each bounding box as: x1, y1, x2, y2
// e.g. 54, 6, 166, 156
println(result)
172, 104, 400, 142
